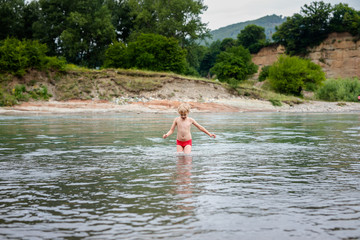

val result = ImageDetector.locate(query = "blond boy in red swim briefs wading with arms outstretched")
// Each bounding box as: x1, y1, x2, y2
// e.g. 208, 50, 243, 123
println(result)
163, 103, 216, 154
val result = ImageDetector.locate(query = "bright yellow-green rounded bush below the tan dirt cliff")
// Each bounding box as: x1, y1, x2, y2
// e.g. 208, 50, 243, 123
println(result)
269, 56, 325, 95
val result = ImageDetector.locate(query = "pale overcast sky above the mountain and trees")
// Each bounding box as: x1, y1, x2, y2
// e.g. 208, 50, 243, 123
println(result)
202, 0, 360, 30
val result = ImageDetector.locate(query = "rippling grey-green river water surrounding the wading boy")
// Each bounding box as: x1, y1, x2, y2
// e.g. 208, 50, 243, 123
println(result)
0, 113, 360, 240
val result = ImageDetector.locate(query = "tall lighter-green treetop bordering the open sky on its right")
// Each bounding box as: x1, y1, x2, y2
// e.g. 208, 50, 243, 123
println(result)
129, 0, 209, 46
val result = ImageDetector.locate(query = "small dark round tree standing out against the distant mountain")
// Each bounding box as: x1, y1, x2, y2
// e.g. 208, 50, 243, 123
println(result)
237, 24, 266, 53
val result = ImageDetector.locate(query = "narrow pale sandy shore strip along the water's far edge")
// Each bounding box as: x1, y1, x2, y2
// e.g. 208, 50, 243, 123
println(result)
0, 98, 360, 114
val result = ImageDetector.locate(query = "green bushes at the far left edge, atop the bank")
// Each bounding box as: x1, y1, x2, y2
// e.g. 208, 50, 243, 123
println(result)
0, 38, 66, 76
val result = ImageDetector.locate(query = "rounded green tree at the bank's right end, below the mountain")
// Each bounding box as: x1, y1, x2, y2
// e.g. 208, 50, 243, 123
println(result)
211, 46, 257, 83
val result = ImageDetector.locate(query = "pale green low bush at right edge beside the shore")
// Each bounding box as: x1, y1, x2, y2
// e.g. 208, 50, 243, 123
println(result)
316, 78, 360, 102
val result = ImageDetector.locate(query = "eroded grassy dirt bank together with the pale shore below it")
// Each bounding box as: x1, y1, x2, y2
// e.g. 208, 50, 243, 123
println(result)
0, 70, 360, 114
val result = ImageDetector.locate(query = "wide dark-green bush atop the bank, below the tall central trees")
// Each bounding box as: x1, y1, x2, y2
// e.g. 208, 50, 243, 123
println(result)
105, 34, 186, 73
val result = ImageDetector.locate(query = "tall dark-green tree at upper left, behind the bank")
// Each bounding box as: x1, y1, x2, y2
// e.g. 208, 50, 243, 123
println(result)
33, 0, 120, 67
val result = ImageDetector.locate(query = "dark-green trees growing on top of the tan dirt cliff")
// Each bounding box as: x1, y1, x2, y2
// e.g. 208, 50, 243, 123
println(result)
273, 1, 360, 55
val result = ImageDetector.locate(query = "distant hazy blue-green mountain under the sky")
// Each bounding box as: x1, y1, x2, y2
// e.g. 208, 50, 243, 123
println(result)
206, 14, 286, 43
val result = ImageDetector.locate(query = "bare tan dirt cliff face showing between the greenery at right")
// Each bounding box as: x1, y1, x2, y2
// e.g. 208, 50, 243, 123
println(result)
253, 33, 360, 78
